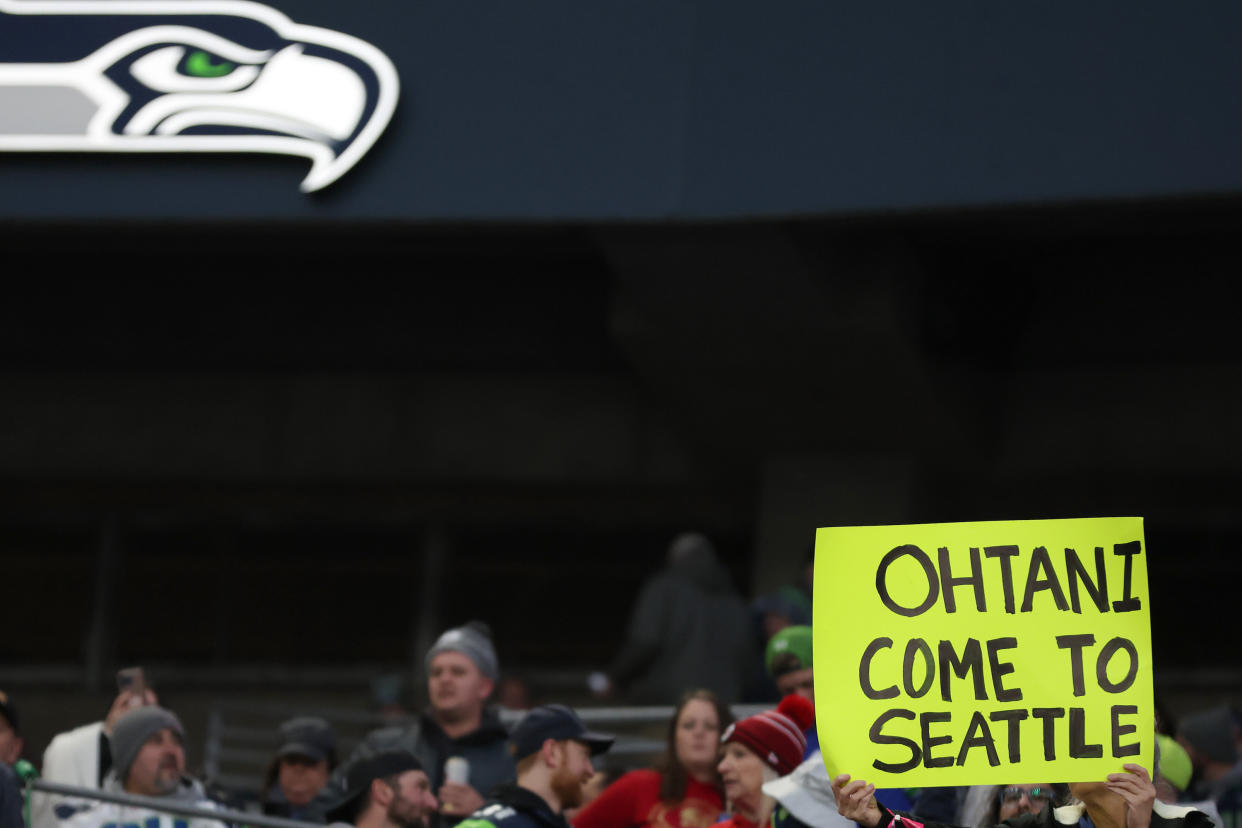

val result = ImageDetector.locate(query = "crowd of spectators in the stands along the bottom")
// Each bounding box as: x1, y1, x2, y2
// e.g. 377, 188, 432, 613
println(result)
0, 534, 1242, 828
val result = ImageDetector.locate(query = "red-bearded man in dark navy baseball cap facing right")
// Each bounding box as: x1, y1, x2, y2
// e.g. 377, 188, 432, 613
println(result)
458, 704, 614, 828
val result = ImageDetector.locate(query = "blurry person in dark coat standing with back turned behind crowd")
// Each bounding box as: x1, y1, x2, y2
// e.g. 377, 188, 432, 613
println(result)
602, 533, 755, 704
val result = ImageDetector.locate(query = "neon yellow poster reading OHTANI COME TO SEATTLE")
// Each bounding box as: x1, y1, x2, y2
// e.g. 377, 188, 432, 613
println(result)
814, 518, 1155, 788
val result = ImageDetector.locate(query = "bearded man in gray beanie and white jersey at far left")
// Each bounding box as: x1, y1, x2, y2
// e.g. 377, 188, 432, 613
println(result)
57, 705, 224, 828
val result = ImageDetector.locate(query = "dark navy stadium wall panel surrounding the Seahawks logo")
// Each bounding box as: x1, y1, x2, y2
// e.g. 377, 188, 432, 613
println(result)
7, 0, 1242, 221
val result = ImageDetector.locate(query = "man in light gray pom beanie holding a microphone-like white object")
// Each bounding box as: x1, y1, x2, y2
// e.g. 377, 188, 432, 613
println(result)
335, 621, 517, 828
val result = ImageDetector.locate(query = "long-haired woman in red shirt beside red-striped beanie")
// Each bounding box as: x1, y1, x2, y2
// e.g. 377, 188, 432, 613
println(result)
574, 690, 733, 828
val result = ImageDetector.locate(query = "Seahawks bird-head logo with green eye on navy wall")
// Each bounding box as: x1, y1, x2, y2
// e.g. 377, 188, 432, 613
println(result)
0, 0, 397, 192
